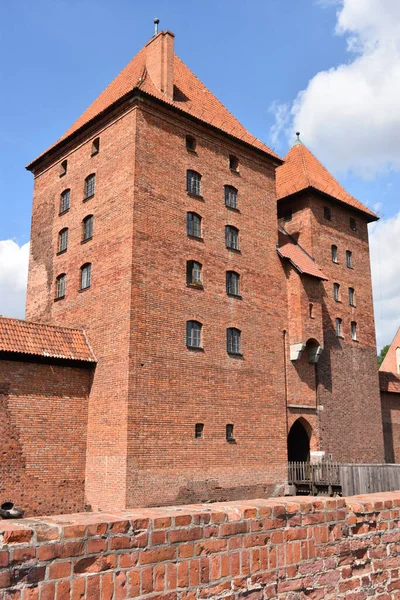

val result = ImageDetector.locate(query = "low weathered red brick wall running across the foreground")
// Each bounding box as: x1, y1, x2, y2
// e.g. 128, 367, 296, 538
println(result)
0, 492, 400, 600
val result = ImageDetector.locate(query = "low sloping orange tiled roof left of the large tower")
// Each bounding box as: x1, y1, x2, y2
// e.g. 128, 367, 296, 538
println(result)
0, 317, 96, 363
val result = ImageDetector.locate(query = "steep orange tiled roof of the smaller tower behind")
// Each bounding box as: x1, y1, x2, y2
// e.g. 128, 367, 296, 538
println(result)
276, 142, 378, 221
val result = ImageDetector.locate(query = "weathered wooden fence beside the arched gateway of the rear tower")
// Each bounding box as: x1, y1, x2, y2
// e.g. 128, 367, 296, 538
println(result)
288, 461, 400, 496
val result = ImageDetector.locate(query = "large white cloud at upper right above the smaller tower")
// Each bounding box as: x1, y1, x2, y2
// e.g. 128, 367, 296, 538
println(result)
271, 0, 400, 178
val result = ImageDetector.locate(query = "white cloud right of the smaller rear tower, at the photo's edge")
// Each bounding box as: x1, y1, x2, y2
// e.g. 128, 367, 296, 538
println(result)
370, 212, 400, 348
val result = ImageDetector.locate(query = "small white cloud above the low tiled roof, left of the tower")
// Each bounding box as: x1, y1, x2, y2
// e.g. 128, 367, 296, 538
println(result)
0, 240, 29, 319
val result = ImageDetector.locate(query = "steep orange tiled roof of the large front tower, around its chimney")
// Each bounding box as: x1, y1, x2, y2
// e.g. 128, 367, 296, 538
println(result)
28, 35, 282, 168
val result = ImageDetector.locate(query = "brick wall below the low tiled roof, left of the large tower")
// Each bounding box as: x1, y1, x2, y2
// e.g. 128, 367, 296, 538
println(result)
0, 359, 91, 516
